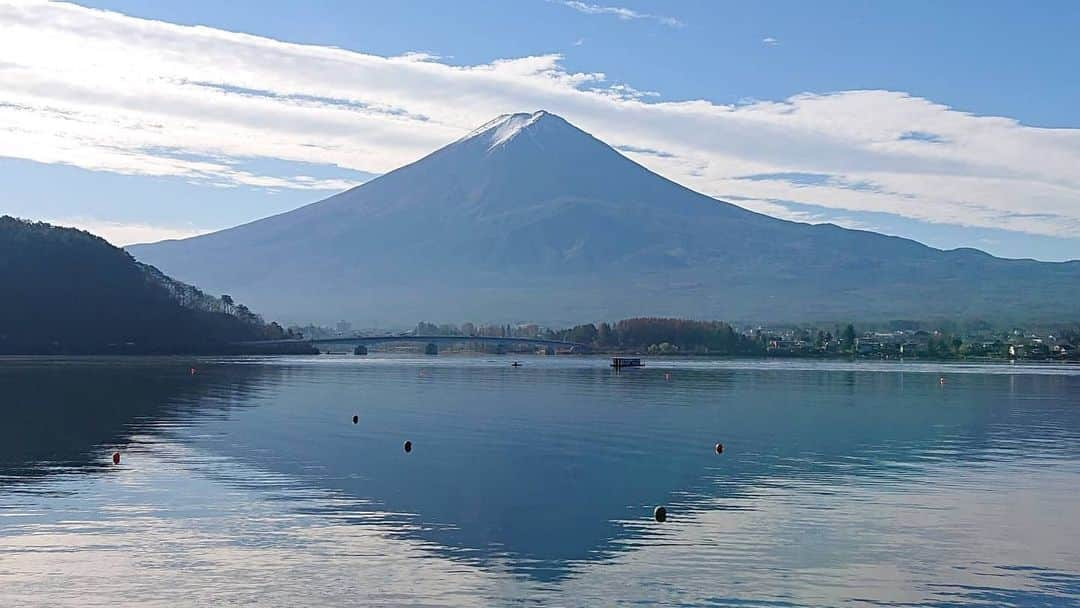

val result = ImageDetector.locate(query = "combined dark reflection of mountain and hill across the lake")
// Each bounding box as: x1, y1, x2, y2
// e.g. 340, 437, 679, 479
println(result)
0, 357, 1080, 582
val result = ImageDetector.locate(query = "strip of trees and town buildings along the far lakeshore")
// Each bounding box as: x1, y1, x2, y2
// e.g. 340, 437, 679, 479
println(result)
289, 317, 1080, 361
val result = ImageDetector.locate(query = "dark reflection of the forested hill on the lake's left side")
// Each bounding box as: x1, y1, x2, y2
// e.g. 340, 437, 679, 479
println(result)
0, 357, 281, 481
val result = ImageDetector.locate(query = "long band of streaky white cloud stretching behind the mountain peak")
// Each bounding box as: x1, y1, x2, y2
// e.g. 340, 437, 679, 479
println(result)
0, 0, 1080, 238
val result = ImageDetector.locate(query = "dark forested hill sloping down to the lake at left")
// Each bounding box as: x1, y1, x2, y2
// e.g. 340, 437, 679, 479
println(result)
0, 216, 304, 354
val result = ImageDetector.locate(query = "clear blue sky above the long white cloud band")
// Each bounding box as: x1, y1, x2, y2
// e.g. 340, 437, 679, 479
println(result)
82, 0, 1080, 127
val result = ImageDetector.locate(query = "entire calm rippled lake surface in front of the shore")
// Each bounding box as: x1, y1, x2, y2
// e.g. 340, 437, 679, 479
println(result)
0, 355, 1080, 607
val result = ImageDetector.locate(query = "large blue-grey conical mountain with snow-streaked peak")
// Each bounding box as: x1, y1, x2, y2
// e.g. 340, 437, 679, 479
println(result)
131, 112, 1080, 323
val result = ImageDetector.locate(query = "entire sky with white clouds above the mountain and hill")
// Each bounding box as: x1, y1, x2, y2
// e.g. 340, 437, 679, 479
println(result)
0, 0, 1080, 259
